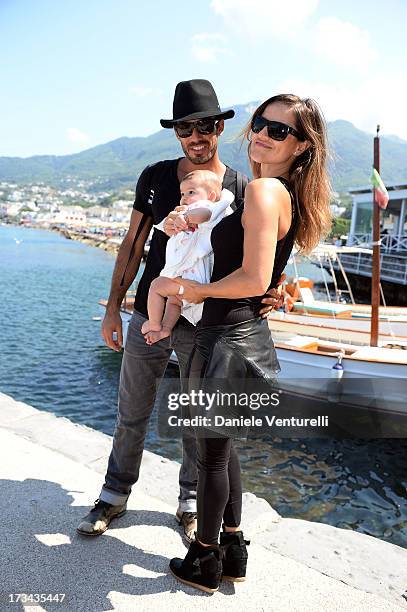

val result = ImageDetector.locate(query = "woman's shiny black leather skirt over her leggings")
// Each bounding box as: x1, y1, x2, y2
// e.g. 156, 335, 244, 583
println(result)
188, 318, 280, 438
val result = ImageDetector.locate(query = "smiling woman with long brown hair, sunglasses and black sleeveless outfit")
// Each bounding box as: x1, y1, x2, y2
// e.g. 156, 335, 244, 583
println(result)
170, 94, 331, 592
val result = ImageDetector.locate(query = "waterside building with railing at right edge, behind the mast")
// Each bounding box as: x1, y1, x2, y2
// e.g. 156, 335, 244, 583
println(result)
341, 182, 407, 305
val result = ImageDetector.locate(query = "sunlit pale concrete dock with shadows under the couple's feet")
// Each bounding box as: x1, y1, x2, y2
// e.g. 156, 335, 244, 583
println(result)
0, 393, 407, 612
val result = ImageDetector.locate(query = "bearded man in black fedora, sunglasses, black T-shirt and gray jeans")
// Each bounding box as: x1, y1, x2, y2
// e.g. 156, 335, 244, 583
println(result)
77, 79, 275, 543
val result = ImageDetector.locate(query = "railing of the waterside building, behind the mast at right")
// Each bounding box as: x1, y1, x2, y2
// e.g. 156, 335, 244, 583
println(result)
341, 253, 407, 285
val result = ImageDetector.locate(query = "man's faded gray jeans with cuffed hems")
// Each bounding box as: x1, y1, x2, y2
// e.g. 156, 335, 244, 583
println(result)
99, 311, 197, 512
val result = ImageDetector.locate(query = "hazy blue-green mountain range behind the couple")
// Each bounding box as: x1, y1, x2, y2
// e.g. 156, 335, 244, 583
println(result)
0, 102, 407, 191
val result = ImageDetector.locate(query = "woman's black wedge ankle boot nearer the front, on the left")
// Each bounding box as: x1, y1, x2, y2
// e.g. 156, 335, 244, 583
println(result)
170, 541, 222, 593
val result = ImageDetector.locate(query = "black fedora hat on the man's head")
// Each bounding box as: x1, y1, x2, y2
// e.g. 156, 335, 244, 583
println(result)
160, 79, 235, 128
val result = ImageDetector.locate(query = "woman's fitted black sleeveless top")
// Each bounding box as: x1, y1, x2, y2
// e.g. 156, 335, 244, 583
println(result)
201, 177, 298, 326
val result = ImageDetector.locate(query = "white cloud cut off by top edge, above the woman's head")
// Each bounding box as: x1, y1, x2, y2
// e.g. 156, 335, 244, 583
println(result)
210, 0, 319, 38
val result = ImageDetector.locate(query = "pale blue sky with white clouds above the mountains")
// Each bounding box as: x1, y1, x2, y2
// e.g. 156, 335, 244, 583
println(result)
0, 0, 407, 157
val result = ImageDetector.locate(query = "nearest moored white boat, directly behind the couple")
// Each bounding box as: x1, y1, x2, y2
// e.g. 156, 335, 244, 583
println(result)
99, 292, 407, 417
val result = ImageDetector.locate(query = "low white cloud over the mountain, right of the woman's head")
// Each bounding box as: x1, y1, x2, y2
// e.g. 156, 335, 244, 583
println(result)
278, 72, 407, 139
